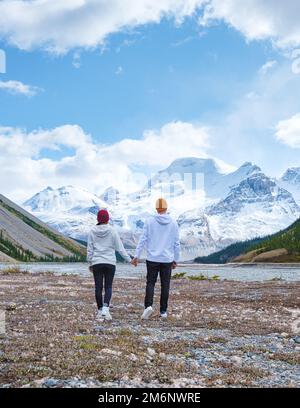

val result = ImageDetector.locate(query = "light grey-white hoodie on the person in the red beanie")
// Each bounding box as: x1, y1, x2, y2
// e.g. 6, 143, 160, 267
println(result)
87, 224, 131, 266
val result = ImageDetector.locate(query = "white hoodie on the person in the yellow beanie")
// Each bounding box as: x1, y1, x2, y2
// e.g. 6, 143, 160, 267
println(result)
135, 214, 180, 263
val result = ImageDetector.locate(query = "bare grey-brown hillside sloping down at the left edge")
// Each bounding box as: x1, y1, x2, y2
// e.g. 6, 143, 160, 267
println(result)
0, 194, 86, 262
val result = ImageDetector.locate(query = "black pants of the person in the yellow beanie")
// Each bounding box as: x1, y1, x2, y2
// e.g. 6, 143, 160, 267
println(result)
145, 261, 172, 313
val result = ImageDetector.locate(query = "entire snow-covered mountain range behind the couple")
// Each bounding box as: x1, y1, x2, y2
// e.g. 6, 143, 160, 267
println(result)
24, 158, 300, 260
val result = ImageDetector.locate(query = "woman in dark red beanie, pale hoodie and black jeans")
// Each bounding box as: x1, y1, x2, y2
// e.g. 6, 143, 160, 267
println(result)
87, 210, 131, 320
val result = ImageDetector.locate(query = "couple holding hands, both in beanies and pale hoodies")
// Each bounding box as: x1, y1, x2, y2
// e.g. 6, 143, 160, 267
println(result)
87, 198, 180, 320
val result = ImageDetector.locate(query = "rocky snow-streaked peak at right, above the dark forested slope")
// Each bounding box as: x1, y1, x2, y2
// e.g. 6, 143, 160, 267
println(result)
207, 173, 300, 246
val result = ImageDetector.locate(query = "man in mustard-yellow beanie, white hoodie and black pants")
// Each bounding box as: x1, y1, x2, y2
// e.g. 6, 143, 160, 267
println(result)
131, 198, 180, 319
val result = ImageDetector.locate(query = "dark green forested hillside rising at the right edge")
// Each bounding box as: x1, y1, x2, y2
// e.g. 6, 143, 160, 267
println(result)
195, 219, 300, 264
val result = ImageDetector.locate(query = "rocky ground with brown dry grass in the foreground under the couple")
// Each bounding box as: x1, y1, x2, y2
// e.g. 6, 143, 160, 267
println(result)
0, 272, 300, 387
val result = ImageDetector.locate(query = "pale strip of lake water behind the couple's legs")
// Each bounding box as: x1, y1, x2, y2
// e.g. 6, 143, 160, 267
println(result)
0, 263, 300, 281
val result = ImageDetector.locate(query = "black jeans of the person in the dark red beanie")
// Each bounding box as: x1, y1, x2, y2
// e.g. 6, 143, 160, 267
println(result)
93, 264, 116, 309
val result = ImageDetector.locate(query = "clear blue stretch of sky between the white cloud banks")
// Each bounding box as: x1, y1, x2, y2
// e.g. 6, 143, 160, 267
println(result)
0, 19, 274, 138
